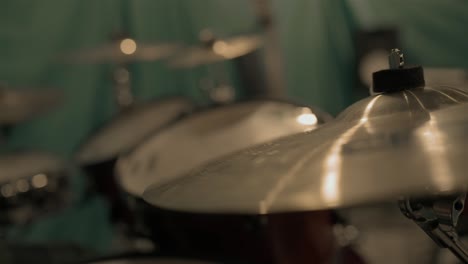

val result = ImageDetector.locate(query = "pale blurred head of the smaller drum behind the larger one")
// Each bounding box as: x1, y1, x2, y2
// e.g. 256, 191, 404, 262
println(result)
76, 98, 193, 165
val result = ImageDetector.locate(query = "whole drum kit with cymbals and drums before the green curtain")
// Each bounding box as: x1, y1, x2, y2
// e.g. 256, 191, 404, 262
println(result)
4, 26, 468, 264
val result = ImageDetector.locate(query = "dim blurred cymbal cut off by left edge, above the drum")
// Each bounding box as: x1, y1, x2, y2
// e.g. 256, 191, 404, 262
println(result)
0, 87, 62, 125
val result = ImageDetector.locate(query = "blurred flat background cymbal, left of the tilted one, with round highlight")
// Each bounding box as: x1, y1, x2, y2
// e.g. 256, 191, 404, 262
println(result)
60, 38, 179, 64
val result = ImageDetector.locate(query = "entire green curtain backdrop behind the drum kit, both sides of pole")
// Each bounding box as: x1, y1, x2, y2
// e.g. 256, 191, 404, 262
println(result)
0, 0, 468, 254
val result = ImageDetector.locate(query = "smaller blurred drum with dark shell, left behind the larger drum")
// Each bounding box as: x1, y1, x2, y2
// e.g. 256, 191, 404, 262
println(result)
75, 97, 194, 221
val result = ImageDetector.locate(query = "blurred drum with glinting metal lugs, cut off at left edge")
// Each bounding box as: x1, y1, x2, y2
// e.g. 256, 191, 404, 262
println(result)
0, 152, 72, 224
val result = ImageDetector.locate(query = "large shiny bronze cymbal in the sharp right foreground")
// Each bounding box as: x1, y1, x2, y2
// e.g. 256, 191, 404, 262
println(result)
143, 87, 468, 214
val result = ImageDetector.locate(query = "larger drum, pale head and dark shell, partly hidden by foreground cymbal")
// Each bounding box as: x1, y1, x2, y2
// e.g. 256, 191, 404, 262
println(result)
116, 100, 331, 263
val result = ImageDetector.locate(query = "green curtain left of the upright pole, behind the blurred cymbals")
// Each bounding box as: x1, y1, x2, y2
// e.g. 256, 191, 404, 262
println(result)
0, 0, 255, 251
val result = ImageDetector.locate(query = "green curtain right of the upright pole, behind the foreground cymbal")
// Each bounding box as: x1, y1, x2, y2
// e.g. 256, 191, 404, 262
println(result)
273, 0, 468, 114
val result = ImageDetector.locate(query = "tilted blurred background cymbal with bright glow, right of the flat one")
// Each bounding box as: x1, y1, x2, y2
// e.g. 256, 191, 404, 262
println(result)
169, 35, 263, 68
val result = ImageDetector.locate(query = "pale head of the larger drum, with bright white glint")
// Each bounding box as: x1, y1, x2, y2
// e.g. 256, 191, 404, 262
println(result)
116, 100, 329, 196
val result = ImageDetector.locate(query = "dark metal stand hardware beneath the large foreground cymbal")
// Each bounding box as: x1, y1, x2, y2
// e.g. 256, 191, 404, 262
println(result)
398, 192, 468, 263
